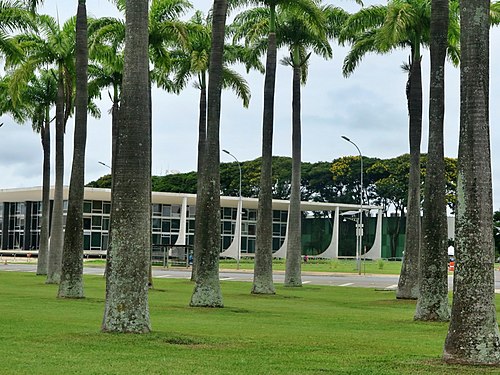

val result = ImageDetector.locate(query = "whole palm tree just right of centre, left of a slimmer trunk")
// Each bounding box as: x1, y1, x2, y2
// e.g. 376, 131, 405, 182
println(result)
230, 0, 336, 294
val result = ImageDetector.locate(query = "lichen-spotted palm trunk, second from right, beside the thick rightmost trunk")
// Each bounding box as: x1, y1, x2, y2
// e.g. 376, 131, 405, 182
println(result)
415, 0, 450, 321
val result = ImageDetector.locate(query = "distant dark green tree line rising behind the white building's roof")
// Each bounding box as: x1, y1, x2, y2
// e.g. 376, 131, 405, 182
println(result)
87, 154, 457, 216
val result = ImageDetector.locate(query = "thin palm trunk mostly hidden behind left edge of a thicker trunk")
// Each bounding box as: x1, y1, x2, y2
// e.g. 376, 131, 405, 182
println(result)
191, 74, 207, 281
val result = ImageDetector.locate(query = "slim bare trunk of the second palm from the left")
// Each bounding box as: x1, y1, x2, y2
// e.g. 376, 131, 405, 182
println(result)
46, 67, 64, 284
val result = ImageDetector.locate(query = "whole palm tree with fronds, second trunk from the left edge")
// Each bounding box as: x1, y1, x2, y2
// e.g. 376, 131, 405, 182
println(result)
7, 15, 75, 284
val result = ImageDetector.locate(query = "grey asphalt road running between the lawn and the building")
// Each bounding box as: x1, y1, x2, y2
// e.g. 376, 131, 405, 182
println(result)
0, 263, 458, 292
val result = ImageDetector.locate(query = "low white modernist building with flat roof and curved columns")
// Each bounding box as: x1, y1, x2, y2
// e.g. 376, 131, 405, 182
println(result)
0, 187, 382, 259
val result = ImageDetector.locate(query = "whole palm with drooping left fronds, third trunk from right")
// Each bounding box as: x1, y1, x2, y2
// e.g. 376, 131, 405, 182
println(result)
342, 0, 458, 299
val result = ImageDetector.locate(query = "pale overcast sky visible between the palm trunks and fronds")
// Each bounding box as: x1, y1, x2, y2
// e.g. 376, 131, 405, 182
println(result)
0, 0, 500, 210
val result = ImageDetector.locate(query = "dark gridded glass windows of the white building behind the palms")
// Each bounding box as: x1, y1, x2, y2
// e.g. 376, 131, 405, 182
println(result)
0, 200, 288, 254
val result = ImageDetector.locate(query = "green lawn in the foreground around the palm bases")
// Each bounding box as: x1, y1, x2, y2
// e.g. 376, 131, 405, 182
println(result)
0, 272, 498, 375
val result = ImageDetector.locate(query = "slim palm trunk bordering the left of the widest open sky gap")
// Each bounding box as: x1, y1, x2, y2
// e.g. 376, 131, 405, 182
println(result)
285, 59, 302, 287
